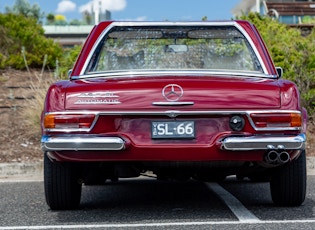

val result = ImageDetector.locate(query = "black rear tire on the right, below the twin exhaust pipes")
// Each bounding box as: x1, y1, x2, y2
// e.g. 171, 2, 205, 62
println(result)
270, 150, 307, 206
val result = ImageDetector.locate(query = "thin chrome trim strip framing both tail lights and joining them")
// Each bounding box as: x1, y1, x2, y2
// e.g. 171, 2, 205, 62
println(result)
44, 110, 302, 133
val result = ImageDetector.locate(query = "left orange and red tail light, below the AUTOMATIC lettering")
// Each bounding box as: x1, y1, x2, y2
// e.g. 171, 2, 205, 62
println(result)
44, 114, 95, 131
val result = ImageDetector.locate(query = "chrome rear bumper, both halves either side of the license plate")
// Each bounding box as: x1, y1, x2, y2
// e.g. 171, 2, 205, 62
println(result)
41, 134, 306, 151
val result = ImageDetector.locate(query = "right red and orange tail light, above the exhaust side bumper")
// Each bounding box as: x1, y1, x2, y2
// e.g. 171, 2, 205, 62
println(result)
250, 113, 302, 129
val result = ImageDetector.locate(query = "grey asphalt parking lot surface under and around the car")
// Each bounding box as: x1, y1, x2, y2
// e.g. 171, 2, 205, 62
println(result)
0, 176, 315, 230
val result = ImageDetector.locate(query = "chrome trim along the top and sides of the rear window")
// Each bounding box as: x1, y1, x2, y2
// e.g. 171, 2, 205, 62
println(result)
78, 21, 270, 79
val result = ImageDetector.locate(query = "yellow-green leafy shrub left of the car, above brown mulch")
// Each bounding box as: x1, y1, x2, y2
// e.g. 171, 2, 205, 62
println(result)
0, 14, 62, 69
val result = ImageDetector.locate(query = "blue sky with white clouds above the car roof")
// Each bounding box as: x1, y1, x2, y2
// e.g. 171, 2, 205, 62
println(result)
0, 0, 241, 21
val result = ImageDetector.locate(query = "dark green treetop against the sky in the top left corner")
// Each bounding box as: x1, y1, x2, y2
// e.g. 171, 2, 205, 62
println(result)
5, 0, 44, 23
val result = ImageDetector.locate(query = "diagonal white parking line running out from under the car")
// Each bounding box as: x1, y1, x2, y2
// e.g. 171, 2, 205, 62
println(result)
206, 183, 260, 223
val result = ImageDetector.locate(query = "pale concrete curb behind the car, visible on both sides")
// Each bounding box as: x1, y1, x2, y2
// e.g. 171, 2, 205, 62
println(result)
0, 157, 315, 182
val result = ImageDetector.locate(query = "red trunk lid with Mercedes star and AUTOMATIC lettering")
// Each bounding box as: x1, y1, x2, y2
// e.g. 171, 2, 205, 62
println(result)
66, 76, 280, 111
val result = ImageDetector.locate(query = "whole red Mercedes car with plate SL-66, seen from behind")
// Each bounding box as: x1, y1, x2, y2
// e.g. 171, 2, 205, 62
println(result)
41, 21, 307, 209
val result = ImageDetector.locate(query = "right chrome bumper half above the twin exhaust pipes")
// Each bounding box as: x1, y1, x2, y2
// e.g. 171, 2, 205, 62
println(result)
221, 134, 306, 151
